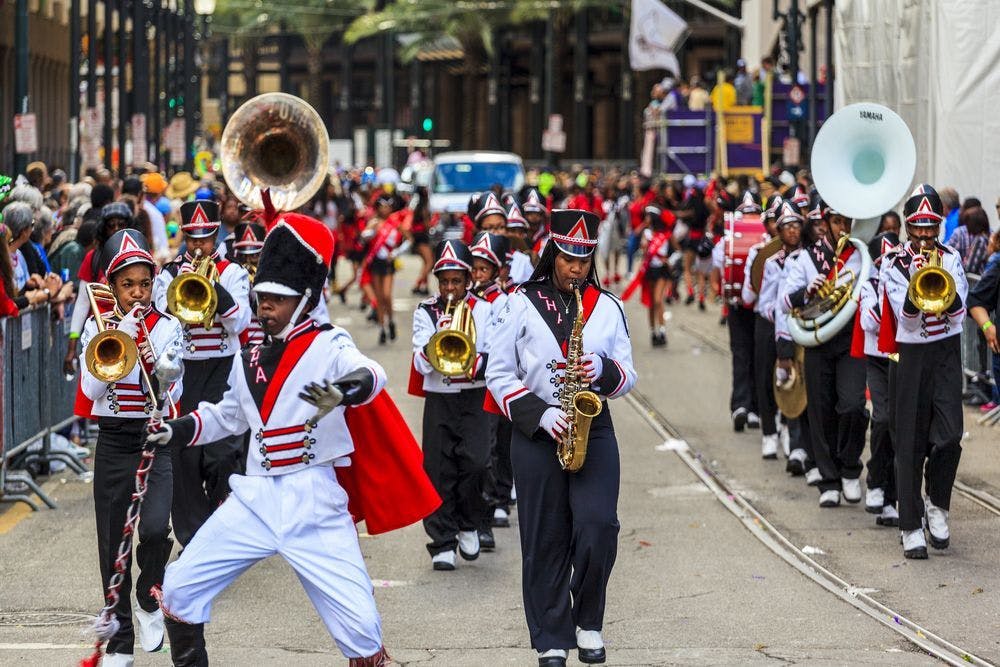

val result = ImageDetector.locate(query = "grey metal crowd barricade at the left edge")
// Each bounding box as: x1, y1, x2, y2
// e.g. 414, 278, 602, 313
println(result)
0, 306, 86, 510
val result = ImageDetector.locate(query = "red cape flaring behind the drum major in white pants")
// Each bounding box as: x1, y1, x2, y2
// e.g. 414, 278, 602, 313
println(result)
336, 391, 441, 535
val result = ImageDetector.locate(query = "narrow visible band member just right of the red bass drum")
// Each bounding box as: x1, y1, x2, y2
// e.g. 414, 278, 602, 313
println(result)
741, 195, 783, 459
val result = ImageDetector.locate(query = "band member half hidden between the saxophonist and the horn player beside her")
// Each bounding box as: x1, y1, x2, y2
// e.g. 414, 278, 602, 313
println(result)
469, 232, 514, 551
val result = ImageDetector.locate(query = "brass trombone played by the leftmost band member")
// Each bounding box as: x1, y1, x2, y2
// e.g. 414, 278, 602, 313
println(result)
84, 283, 174, 410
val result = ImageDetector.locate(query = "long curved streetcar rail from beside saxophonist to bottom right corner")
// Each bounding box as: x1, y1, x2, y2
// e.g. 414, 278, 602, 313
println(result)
625, 389, 1000, 667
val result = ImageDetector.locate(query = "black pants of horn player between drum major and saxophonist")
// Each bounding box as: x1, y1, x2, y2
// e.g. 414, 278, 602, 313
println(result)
424, 387, 497, 556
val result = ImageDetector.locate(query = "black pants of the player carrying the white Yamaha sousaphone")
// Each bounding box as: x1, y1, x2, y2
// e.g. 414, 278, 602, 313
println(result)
805, 326, 868, 492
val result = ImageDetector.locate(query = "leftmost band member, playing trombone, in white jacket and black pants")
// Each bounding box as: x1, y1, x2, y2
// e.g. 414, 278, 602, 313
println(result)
80, 229, 183, 667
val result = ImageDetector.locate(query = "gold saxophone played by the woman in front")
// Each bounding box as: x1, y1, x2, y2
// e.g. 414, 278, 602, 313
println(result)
556, 281, 603, 472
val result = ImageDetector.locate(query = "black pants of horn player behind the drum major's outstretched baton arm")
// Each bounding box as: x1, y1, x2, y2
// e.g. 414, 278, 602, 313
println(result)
171, 356, 244, 546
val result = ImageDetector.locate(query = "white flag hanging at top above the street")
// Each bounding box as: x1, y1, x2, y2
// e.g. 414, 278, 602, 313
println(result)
628, 0, 687, 76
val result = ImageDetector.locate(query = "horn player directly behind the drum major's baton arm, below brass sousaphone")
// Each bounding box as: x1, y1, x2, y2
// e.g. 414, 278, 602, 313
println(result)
153, 200, 250, 545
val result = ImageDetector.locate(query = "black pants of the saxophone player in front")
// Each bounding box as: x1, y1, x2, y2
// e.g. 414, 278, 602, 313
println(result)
510, 405, 620, 651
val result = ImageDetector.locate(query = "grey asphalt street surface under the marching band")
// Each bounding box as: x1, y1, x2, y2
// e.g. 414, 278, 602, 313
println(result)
0, 258, 984, 666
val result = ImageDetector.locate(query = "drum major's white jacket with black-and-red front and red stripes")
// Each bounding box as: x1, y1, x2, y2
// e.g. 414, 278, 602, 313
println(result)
181, 319, 386, 475
